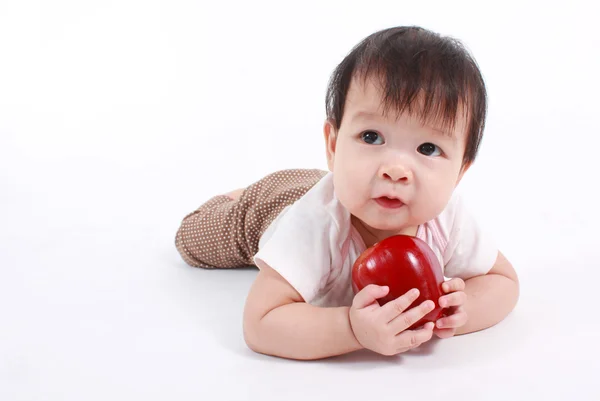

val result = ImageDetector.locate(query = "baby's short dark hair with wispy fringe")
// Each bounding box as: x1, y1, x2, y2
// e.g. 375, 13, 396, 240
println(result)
325, 26, 487, 167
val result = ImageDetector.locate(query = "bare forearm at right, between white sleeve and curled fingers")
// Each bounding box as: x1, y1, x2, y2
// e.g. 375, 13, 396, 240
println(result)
456, 274, 519, 334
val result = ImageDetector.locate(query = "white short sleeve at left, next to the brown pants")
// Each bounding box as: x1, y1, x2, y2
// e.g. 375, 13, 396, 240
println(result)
254, 203, 337, 303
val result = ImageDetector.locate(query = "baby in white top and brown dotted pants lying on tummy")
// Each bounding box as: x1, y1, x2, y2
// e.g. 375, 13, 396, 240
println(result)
175, 26, 519, 359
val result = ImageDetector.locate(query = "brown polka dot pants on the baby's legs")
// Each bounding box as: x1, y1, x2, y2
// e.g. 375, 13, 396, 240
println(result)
175, 169, 327, 268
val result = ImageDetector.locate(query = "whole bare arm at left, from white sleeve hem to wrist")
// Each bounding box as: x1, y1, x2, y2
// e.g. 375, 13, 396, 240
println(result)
244, 266, 363, 360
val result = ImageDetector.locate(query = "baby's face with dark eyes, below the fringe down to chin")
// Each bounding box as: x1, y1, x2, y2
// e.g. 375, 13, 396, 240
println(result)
325, 76, 466, 240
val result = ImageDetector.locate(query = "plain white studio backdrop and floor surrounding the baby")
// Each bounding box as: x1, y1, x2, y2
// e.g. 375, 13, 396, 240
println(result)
0, 0, 600, 401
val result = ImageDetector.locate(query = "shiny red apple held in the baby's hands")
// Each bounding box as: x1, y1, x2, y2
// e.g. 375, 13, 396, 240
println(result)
352, 235, 446, 330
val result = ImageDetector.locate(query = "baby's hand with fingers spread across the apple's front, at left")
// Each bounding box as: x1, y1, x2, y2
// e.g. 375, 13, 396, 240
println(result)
350, 284, 435, 355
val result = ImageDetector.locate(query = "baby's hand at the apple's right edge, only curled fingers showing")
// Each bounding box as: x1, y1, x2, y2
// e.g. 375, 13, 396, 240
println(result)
433, 278, 468, 338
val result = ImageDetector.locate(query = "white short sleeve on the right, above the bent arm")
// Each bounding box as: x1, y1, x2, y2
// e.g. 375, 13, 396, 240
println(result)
444, 196, 498, 280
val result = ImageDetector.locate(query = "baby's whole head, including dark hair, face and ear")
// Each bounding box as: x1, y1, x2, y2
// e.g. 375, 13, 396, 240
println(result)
324, 27, 486, 239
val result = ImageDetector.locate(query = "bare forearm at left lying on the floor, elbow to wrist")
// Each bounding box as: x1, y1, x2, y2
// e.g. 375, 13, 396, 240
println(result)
251, 302, 362, 360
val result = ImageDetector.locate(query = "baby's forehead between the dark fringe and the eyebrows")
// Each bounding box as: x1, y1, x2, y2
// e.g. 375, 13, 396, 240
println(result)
343, 78, 468, 140
